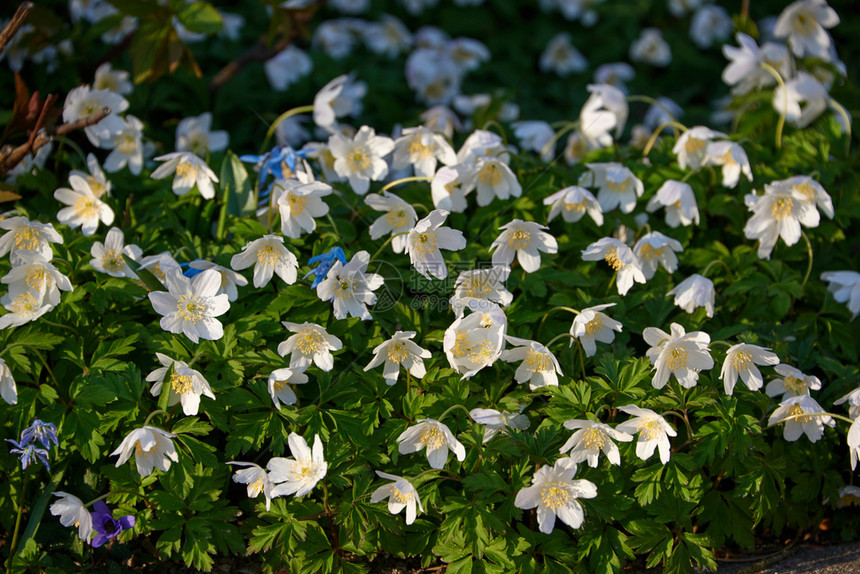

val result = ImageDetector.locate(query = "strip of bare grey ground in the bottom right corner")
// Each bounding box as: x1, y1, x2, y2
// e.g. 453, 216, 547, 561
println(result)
717, 542, 860, 574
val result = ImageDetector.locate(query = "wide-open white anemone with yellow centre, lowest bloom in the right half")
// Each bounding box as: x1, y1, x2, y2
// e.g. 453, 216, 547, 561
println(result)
514, 457, 597, 534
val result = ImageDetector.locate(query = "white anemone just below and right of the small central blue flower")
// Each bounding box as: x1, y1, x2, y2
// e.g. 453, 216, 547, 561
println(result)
317, 251, 384, 321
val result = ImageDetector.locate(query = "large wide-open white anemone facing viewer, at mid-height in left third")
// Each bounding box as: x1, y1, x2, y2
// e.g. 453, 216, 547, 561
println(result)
148, 269, 230, 343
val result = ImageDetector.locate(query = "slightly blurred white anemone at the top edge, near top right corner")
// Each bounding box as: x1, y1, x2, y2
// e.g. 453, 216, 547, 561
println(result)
773, 0, 839, 62
